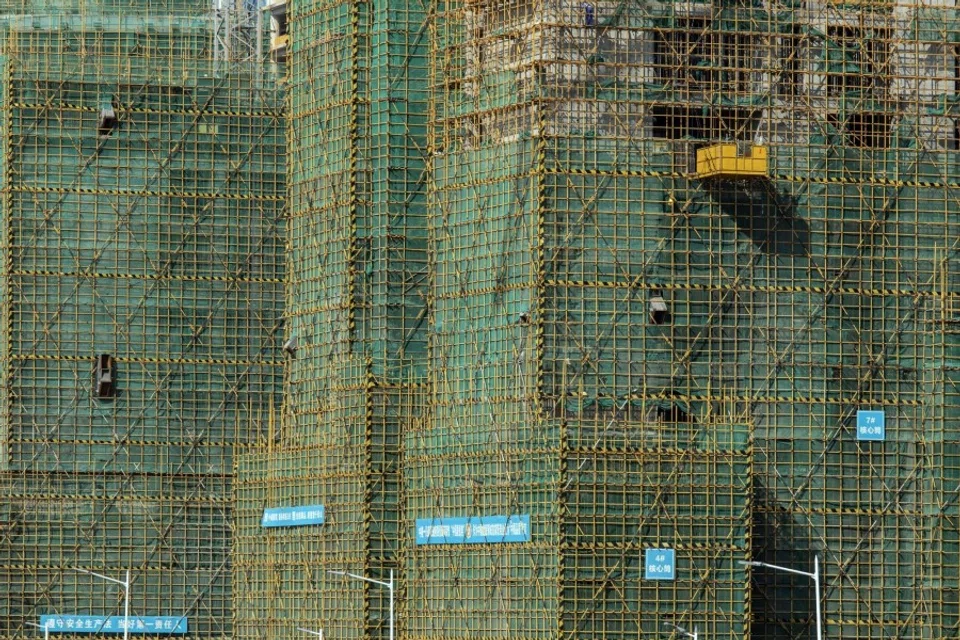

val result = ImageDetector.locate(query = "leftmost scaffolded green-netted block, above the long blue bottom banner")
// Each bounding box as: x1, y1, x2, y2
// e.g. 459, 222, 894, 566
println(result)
0, 2, 285, 639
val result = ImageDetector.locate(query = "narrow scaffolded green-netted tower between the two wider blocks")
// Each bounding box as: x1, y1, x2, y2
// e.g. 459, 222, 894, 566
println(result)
234, 0, 428, 639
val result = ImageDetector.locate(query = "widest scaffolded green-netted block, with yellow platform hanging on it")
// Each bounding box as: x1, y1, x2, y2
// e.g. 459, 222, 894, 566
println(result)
424, 0, 960, 638
